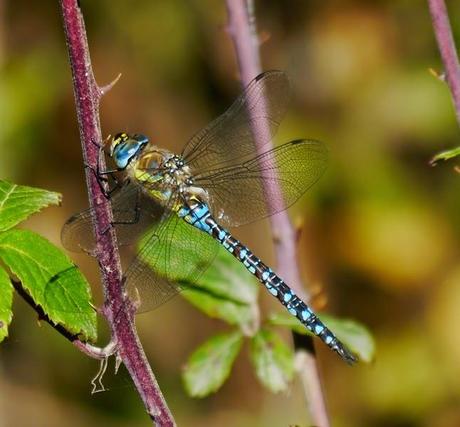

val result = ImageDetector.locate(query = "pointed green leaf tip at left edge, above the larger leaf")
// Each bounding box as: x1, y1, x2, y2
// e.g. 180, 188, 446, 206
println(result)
0, 180, 61, 231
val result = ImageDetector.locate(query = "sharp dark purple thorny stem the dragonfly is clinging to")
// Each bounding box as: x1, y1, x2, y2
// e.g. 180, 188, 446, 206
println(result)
60, 0, 175, 427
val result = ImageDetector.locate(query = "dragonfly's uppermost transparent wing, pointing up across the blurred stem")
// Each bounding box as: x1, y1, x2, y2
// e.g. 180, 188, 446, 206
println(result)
182, 71, 290, 172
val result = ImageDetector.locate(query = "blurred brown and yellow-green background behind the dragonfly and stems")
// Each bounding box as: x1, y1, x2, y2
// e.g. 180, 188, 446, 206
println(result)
0, 0, 460, 427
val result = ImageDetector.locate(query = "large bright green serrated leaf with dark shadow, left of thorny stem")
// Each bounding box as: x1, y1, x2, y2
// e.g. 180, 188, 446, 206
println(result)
0, 230, 97, 341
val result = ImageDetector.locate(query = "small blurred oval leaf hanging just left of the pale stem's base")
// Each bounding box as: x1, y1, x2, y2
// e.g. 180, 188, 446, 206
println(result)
251, 329, 294, 393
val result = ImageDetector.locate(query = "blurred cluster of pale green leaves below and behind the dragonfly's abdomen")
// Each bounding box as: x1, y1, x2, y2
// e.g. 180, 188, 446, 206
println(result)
180, 247, 366, 397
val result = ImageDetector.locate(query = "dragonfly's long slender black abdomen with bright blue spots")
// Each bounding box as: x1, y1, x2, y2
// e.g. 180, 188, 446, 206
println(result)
178, 202, 356, 363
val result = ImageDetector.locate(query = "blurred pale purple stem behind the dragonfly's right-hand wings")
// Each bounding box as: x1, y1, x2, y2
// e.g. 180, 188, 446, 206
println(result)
226, 0, 330, 427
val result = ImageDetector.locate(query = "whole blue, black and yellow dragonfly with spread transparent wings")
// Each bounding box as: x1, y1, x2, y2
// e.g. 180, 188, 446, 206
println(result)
62, 71, 356, 363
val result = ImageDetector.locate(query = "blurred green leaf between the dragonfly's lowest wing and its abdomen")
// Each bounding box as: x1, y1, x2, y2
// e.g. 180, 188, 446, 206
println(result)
183, 250, 259, 330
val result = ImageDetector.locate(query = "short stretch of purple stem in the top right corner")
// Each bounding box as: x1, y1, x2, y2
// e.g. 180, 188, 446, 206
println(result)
428, 0, 460, 126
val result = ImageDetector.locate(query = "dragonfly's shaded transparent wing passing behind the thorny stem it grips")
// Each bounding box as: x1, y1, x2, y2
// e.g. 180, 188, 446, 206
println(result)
61, 182, 164, 252
